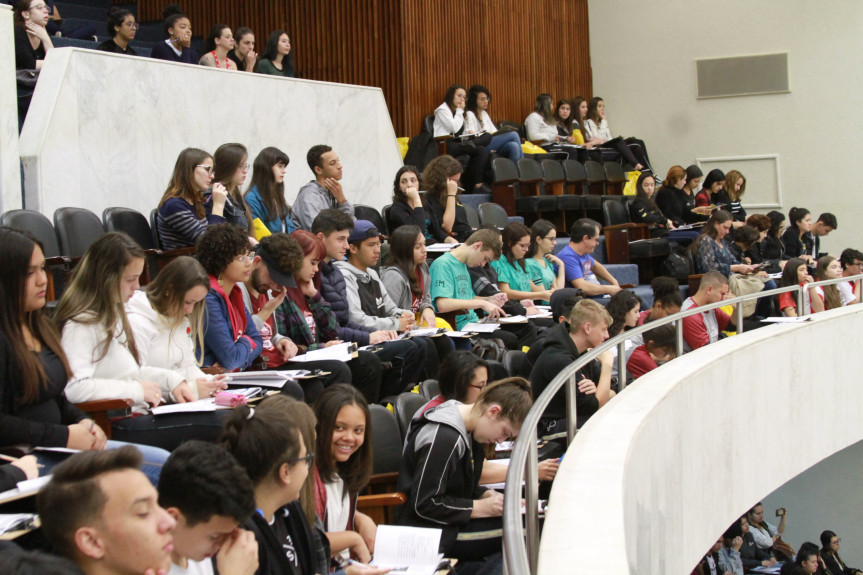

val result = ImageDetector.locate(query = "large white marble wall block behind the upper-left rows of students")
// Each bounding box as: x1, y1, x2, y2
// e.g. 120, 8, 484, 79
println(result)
21, 48, 402, 217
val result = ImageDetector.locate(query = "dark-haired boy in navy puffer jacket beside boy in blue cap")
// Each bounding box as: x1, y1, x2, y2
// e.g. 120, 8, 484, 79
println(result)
312, 210, 425, 397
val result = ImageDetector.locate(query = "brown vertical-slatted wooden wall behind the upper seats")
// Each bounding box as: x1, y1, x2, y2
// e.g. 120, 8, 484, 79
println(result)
138, 0, 592, 136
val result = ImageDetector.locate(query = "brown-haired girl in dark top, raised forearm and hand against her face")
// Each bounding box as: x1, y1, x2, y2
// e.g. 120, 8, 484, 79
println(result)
423, 155, 473, 244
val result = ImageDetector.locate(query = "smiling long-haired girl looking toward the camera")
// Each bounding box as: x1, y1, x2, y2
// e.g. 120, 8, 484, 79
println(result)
313, 384, 377, 563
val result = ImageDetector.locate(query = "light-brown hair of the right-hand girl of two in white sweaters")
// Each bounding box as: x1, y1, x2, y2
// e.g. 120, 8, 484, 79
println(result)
144, 256, 210, 365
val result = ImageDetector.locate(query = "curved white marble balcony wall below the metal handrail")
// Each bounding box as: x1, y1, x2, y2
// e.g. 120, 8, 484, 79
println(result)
538, 306, 863, 575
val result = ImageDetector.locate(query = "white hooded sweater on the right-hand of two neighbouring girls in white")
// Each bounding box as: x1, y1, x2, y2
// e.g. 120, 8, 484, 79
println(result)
126, 291, 207, 401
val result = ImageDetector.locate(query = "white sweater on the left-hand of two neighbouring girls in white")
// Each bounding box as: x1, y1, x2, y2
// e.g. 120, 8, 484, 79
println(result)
60, 310, 183, 403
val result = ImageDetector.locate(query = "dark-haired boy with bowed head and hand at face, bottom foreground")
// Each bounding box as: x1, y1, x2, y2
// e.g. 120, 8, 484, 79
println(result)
158, 440, 258, 575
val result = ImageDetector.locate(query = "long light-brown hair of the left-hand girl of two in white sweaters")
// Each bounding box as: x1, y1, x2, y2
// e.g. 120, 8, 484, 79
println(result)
54, 232, 144, 363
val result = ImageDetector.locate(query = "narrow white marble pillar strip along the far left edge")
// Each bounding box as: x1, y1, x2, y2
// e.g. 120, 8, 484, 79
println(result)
0, 4, 21, 212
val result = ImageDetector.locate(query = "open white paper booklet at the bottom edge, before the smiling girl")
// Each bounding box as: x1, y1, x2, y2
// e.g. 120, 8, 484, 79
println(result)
371, 525, 443, 575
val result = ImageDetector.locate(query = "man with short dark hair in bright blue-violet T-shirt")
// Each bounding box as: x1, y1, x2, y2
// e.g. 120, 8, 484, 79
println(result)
557, 218, 620, 298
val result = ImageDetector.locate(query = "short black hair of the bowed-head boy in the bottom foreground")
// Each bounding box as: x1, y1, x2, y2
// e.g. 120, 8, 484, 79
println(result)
159, 440, 255, 527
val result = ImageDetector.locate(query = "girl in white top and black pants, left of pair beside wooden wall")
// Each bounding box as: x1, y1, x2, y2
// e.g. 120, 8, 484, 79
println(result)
436, 84, 492, 192
